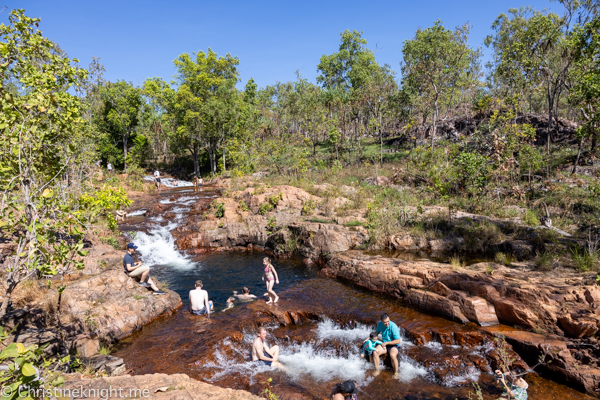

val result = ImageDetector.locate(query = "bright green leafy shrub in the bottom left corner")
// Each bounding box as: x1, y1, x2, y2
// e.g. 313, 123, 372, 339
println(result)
0, 327, 70, 400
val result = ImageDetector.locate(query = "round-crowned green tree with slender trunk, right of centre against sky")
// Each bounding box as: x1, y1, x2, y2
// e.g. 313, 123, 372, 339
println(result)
402, 20, 479, 147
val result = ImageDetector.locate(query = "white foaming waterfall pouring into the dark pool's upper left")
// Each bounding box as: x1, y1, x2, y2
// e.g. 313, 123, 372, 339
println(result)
135, 222, 196, 269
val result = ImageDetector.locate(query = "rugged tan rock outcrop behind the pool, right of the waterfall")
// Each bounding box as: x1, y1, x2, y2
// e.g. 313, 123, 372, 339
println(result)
176, 186, 369, 259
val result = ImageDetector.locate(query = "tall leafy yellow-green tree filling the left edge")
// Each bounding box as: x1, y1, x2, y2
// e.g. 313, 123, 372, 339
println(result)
0, 10, 131, 318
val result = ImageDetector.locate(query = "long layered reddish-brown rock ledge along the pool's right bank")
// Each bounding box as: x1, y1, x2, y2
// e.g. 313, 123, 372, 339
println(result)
321, 251, 600, 394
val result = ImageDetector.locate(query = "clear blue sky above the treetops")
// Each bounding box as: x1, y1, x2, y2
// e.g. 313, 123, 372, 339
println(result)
0, 0, 562, 87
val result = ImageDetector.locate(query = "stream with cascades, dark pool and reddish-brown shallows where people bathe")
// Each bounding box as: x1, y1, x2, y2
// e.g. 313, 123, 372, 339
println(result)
114, 187, 592, 400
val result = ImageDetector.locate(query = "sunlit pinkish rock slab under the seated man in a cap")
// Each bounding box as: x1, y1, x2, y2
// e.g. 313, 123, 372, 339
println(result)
62, 270, 181, 342
